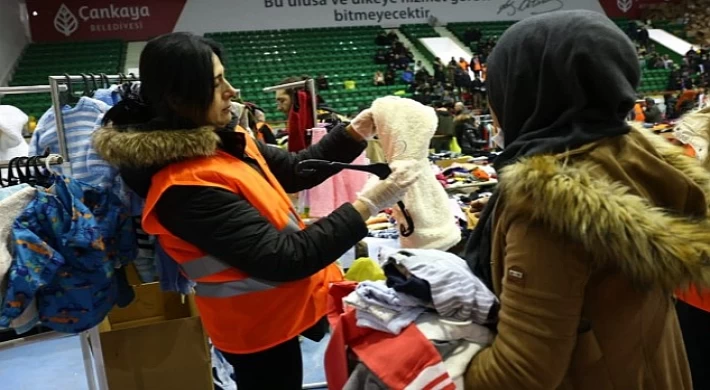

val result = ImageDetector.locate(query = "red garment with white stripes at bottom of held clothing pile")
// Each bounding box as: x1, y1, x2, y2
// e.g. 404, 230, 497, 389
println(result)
325, 282, 456, 390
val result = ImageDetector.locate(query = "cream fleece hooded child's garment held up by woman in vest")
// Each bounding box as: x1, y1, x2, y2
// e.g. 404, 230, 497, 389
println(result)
371, 96, 461, 250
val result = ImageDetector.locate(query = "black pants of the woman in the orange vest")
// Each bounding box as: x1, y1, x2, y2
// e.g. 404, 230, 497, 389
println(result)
222, 337, 303, 390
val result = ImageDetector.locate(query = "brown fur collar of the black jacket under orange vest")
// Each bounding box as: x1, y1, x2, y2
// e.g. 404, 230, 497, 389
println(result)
92, 127, 246, 168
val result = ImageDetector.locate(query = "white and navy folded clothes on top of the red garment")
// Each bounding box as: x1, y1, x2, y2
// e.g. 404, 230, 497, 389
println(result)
343, 249, 498, 334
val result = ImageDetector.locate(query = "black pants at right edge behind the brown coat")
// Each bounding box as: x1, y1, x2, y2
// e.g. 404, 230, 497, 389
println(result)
676, 300, 710, 390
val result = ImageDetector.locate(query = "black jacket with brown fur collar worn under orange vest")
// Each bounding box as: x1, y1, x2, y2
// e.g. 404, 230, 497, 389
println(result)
94, 125, 367, 282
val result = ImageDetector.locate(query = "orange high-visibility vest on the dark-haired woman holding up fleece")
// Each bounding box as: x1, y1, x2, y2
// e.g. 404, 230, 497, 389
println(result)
143, 129, 342, 354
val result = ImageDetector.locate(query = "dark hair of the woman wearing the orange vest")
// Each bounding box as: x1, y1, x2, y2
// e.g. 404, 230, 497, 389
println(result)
103, 32, 223, 129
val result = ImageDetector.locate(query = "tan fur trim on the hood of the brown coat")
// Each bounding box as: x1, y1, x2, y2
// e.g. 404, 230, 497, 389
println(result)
500, 131, 710, 291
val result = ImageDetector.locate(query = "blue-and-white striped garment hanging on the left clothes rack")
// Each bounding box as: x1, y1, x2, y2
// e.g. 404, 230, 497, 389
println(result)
29, 97, 143, 215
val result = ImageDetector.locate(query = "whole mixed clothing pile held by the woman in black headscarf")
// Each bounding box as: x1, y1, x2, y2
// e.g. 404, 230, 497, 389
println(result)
325, 249, 498, 390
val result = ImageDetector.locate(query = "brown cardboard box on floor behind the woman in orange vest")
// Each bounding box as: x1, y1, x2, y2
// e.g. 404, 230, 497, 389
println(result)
100, 283, 214, 390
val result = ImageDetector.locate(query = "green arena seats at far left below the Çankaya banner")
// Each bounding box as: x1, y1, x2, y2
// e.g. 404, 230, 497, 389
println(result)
0, 40, 125, 118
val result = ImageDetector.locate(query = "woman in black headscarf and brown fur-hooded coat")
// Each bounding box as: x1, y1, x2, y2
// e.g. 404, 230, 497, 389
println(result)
466, 11, 710, 390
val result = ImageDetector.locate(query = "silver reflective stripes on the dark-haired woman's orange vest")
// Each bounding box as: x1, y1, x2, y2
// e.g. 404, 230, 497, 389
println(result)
179, 209, 301, 298
